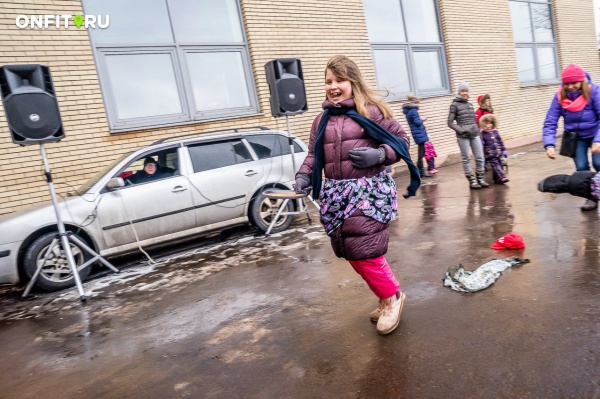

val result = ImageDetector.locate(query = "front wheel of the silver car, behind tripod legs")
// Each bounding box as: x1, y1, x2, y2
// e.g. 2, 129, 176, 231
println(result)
23, 232, 92, 291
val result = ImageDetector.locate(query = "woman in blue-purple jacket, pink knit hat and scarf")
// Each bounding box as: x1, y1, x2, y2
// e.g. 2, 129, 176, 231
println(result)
543, 64, 600, 211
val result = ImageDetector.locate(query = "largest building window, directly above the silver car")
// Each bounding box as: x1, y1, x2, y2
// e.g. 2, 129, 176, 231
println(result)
83, 0, 258, 131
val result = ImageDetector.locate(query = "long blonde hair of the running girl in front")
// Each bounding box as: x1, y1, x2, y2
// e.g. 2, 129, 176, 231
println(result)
325, 55, 394, 118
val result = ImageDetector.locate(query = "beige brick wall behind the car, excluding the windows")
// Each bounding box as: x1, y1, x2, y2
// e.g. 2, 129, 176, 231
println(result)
0, 0, 600, 214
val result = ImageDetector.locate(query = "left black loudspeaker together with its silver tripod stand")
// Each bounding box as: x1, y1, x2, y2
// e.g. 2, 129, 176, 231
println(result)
0, 64, 119, 302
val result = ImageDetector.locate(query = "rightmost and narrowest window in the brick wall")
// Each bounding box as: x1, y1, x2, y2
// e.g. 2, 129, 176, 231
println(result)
510, 0, 558, 85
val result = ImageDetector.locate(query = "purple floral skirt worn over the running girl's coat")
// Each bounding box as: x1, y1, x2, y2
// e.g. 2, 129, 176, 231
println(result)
320, 171, 398, 236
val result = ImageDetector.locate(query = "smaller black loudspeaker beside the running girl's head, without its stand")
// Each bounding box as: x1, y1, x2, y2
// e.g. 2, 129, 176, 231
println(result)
265, 58, 308, 117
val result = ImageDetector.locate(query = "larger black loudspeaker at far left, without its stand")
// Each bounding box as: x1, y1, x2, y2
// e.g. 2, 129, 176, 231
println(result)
0, 64, 65, 145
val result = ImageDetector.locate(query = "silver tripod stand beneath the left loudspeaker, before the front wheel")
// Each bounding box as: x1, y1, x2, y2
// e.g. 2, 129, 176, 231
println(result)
22, 143, 119, 302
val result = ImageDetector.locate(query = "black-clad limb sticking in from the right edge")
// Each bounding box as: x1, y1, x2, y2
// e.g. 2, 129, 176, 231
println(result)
538, 170, 600, 205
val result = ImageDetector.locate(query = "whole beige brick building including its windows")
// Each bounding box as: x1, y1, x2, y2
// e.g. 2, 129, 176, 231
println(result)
0, 0, 600, 214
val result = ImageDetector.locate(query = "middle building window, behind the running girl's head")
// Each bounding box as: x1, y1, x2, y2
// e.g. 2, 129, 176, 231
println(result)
364, 0, 449, 99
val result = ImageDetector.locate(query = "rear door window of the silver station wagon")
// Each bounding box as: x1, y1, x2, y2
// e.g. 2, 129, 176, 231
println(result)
188, 140, 252, 173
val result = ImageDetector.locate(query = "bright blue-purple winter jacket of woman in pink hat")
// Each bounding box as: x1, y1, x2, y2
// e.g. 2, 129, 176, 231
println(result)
543, 75, 600, 147
